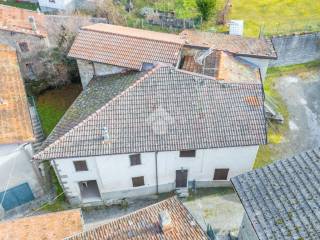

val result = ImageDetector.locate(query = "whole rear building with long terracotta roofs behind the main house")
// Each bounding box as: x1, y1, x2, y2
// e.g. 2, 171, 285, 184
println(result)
68, 23, 277, 88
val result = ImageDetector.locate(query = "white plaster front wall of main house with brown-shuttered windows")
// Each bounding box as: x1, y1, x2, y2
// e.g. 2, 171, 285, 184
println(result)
55, 146, 258, 202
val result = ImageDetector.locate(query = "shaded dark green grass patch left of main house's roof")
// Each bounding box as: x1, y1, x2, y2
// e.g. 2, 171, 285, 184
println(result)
37, 84, 82, 136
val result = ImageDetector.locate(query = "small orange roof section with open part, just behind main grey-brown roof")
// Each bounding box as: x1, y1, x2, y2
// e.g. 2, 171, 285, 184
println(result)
182, 51, 262, 84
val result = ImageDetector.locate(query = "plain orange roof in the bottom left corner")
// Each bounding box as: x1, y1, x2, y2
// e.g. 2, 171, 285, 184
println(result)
0, 209, 83, 240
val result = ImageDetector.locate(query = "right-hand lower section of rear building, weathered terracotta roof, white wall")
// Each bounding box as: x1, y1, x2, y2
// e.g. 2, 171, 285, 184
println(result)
180, 29, 277, 80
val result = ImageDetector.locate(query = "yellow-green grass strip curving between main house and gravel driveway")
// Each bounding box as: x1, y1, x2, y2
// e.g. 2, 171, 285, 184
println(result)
254, 61, 320, 168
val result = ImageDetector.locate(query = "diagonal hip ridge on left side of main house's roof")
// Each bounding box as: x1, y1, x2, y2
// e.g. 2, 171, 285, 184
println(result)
33, 64, 163, 159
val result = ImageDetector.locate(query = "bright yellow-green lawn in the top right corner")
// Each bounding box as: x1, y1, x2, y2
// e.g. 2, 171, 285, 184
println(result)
229, 0, 320, 37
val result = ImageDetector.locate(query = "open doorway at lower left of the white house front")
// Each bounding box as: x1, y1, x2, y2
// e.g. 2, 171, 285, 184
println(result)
79, 180, 101, 202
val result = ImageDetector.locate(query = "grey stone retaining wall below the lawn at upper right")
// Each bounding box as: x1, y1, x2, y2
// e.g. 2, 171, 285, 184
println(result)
270, 32, 320, 67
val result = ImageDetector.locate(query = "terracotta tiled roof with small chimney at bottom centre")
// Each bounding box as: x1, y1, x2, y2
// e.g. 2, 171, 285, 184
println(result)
67, 197, 209, 240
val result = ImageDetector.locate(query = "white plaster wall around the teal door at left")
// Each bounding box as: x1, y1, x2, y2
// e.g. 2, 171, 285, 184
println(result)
0, 144, 42, 197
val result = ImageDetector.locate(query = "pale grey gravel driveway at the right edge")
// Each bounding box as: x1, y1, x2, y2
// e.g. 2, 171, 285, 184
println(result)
276, 70, 320, 158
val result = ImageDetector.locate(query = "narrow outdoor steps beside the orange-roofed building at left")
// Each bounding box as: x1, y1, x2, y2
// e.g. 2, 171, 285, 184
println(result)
29, 98, 45, 153
